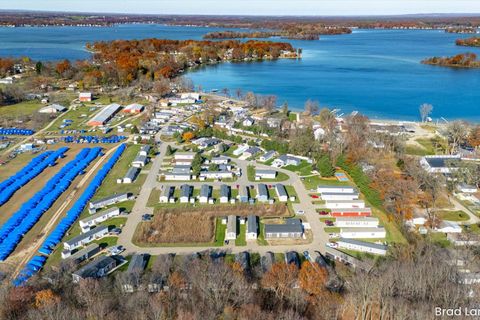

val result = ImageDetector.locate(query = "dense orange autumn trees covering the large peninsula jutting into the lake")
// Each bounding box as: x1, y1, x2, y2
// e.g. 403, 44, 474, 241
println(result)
87, 39, 297, 85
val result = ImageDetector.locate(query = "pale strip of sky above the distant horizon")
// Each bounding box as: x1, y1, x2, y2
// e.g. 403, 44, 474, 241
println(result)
0, 0, 480, 16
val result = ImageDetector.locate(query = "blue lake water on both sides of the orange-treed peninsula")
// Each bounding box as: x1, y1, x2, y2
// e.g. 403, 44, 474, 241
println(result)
0, 24, 480, 121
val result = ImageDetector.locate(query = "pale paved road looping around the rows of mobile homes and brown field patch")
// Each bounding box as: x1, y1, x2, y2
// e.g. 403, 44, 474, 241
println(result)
118, 141, 328, 255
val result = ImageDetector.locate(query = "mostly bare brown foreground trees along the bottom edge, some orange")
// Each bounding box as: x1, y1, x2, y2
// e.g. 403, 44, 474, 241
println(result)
0, 239, 478, 320
